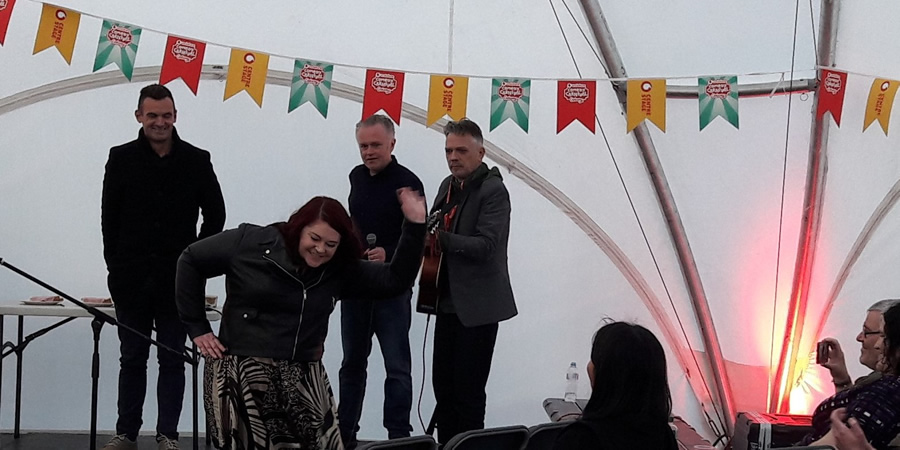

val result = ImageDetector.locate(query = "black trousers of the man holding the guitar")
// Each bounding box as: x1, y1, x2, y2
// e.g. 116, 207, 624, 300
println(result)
431, 314, 499, 444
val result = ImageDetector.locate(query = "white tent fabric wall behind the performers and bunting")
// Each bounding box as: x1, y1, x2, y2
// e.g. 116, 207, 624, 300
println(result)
0, 0, 900, 437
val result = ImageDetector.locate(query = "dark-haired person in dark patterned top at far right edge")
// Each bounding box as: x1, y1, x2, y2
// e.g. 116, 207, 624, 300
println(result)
799, 305, 900, 449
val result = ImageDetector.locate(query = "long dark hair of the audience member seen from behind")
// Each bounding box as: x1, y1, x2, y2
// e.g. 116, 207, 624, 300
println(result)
584, 322, 672, 422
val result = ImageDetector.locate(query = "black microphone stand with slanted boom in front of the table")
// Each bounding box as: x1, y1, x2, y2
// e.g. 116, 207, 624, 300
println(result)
0, 258, 199, 450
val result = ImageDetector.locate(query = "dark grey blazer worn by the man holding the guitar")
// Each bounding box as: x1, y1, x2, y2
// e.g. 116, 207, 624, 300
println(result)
433, 167, 518, 327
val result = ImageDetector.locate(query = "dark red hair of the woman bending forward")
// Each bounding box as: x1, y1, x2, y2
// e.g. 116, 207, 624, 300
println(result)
275, 197, 362, 267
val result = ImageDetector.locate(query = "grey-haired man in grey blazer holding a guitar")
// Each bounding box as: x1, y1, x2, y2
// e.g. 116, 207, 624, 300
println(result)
432, 119, 517, 443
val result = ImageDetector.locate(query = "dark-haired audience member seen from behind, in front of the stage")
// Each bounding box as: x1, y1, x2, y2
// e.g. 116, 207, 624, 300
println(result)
553, 322, 678, 450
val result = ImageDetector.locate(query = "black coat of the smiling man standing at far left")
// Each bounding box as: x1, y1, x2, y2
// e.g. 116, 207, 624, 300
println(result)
101, 126, 225, 278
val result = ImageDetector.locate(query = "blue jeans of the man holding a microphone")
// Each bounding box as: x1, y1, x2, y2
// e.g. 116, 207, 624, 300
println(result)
338, 289, 412, 448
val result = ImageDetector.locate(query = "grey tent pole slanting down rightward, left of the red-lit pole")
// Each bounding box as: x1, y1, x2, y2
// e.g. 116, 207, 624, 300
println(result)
581, 0, 735, 436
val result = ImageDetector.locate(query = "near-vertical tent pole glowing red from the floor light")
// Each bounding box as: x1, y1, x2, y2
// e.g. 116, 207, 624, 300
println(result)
769, 0, 840, 413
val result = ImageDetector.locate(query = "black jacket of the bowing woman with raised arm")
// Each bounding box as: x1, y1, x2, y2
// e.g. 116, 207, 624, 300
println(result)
175, 223, 425, 361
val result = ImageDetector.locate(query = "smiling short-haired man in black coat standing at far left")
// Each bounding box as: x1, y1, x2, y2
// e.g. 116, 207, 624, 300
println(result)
101, 84, 225, 450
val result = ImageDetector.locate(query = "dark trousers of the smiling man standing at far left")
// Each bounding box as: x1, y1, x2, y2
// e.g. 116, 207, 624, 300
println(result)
110, 273, 186, 439
